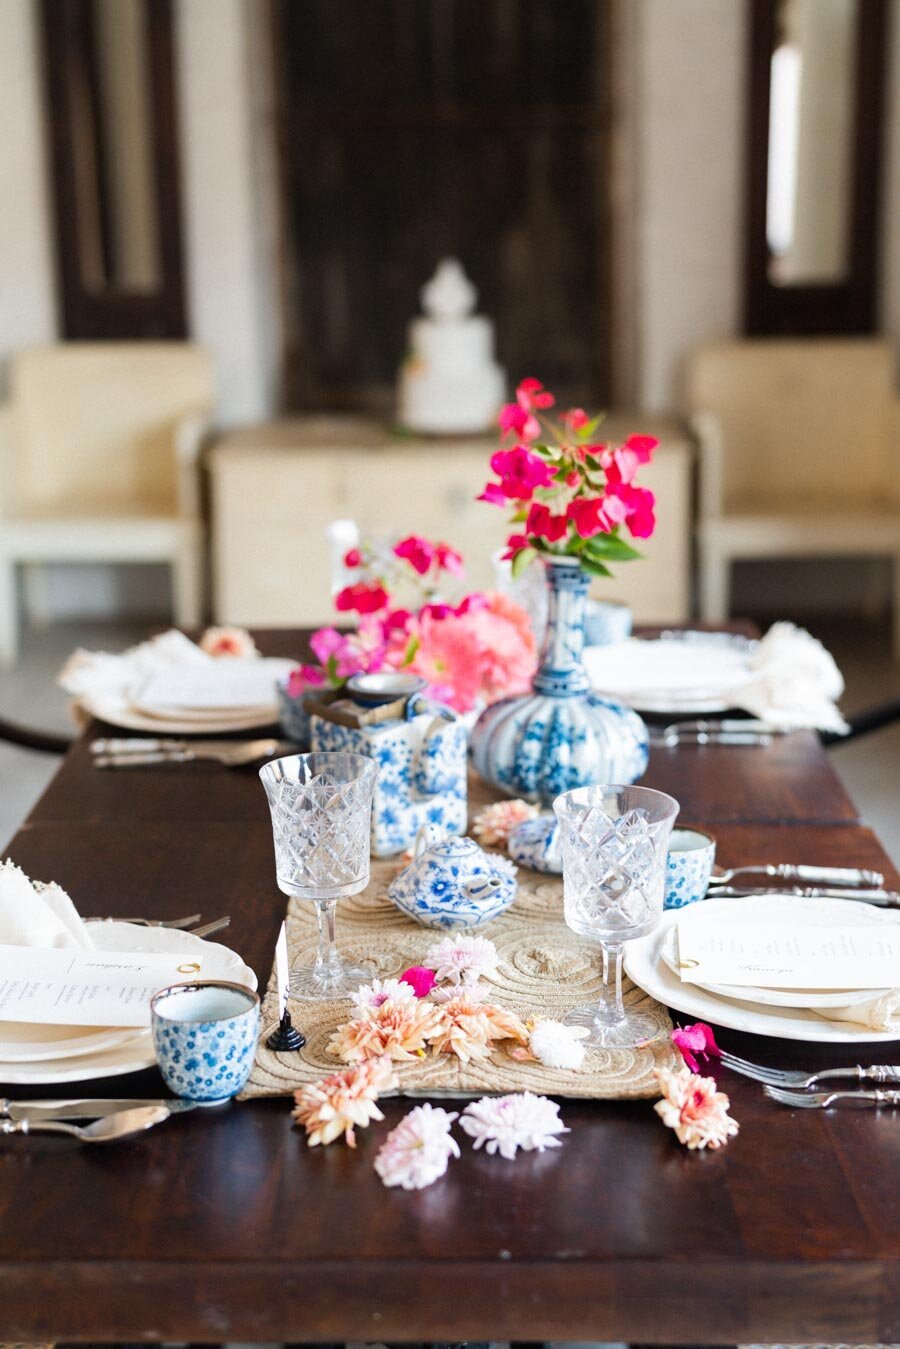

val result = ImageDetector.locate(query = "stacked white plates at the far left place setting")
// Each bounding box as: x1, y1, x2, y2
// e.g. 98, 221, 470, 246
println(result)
81, 657, 296, 735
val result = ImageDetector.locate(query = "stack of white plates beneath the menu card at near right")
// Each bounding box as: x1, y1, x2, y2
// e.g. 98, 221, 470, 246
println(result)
625, 894, 900, 1044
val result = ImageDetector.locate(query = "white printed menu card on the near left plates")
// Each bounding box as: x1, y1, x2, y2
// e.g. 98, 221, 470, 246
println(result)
0, 946, 202, 1027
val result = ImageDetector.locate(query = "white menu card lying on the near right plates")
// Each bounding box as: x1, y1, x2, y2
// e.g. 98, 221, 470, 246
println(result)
677, 915, 900, 990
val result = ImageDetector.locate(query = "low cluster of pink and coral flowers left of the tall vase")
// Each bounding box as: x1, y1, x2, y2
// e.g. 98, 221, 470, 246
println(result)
287, 534, 537, 712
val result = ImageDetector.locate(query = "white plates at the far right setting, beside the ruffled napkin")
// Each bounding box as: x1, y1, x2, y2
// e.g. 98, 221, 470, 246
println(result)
584, 631, 753, 714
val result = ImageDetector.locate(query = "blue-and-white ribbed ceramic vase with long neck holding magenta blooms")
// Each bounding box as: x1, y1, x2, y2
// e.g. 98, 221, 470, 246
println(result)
470, 557, 648, 805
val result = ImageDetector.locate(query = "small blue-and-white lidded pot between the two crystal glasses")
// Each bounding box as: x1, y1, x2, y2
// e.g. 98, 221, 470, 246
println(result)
387, 826, 517, 928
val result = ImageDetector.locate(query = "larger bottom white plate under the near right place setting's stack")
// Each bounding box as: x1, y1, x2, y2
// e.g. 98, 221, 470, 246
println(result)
625, 896, 900, 1044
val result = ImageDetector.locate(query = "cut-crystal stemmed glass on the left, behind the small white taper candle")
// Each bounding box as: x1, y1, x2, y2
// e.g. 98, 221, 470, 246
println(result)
259, 754, 378, 998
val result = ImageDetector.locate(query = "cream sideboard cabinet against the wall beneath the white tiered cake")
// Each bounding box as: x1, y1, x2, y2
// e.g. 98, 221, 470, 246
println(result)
208, 414, 692, 627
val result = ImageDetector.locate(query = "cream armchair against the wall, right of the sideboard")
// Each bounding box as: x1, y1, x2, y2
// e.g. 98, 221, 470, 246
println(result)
688, 337, 900, 654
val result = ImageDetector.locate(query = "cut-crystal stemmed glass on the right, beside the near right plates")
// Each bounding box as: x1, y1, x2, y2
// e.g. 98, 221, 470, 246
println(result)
553, 786, 679, 1048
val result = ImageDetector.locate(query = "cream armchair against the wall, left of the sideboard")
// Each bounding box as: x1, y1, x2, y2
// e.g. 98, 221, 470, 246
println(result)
0, 343, 213, 664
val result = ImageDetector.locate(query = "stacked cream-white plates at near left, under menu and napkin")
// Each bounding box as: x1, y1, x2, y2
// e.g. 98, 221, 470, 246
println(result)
0, 921, 256, 1086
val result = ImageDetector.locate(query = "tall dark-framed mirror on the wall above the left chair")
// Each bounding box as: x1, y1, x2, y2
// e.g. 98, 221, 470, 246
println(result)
43, 0, 185, 337
